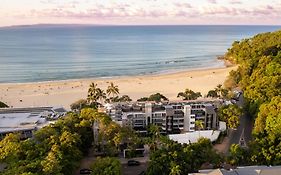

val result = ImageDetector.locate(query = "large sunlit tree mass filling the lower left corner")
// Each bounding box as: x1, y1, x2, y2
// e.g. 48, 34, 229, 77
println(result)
0, 108, 127, 175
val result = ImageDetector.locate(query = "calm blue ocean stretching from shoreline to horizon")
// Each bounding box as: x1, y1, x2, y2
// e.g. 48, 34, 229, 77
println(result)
0, 25, 281, 83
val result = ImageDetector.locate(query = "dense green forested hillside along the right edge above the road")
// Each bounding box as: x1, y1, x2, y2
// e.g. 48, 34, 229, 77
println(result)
223, 31, 281, 165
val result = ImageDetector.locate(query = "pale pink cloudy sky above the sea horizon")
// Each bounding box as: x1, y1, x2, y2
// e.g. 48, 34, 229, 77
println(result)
0, 0, 281, 26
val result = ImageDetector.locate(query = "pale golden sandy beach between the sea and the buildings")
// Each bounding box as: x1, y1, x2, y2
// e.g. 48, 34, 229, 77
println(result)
0, 66, 237, 109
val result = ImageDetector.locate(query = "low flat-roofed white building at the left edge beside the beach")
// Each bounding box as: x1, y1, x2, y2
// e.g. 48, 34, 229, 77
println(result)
0, 107, 67, 140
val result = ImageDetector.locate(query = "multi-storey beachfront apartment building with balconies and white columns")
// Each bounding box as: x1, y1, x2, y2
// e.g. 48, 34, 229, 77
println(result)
105, 102, 218, 134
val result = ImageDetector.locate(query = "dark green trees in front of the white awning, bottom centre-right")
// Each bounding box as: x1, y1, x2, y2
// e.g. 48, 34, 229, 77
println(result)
146, 138, 221, 175
